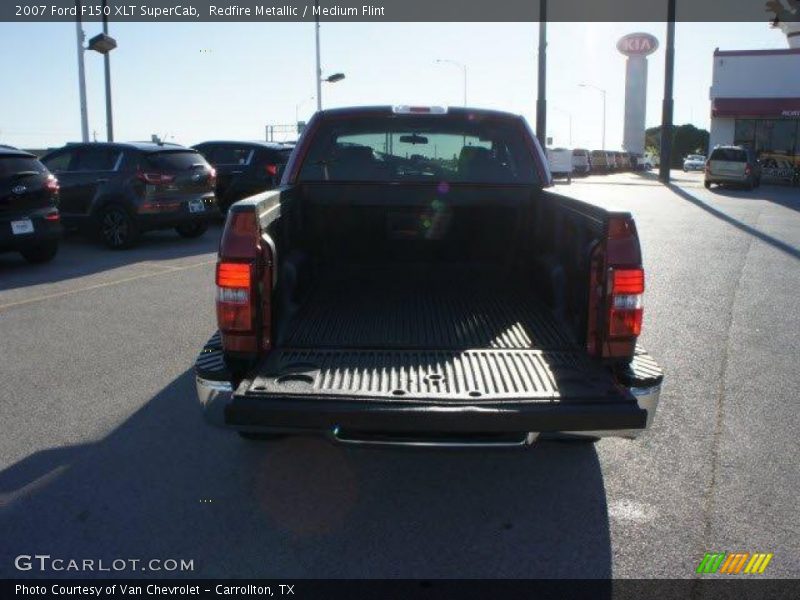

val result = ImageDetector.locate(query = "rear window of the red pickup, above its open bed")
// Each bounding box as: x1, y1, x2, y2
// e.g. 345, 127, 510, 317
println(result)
299, 115, 539, 184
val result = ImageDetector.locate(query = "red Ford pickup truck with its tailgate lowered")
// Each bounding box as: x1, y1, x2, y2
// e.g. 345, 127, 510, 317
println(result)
195, 106, 663, 446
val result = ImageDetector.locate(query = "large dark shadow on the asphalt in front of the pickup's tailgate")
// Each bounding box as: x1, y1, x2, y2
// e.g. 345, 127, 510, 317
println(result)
0, 371, 611, 578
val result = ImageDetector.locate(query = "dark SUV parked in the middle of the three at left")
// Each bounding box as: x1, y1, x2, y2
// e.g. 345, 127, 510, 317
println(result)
42, 142, 219, 248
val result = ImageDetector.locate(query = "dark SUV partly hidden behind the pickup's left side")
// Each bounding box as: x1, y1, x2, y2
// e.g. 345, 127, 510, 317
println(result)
192, 142, 293, 212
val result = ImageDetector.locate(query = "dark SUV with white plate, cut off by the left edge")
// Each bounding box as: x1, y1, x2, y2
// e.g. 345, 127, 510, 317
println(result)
0, 146, 61, 263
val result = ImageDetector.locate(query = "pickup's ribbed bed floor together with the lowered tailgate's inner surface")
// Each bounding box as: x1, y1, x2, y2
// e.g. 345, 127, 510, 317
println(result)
240, 265, 625, 405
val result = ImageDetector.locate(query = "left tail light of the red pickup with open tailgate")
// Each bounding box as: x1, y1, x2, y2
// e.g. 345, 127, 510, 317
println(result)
217, 262, 253, 332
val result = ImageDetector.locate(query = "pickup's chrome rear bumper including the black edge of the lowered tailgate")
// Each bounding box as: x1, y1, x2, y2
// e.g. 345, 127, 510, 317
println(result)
195, 336, 663, 445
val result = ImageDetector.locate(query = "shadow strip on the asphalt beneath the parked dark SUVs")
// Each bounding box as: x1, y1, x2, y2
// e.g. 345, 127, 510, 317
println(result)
0, 222, 222, 290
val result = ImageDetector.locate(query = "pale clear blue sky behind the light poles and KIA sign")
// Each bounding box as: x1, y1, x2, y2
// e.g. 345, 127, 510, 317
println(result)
0, 21, 786, 149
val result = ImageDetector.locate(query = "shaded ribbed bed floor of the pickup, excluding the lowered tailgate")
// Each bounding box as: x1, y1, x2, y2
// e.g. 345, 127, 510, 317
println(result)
279, 269, 578, 350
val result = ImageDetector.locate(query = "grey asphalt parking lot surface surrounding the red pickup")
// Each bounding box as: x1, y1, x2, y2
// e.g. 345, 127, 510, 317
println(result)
0, 172, 800, 578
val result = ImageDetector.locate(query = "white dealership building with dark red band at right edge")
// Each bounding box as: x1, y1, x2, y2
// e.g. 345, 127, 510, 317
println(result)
709, 40, 800, 181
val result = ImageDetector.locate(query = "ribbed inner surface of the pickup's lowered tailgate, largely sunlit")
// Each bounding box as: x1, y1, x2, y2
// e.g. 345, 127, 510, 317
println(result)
237, 348, 630, 405
